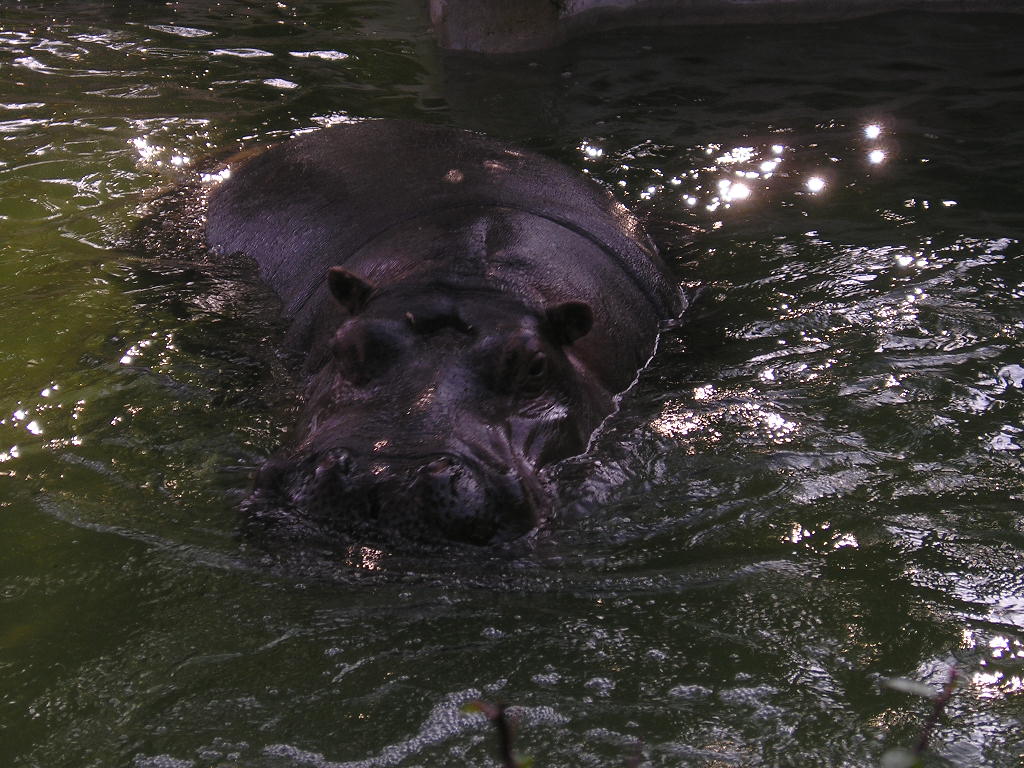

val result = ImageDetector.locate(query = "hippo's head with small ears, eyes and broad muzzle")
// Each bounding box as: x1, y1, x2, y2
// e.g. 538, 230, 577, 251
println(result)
245, 267, 610, 545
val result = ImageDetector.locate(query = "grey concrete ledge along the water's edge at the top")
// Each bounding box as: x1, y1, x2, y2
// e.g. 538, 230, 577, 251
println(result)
430, 0, 1024, 53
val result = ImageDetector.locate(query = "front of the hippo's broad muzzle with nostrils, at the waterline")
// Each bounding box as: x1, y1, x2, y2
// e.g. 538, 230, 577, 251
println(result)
242, 449, 550, 546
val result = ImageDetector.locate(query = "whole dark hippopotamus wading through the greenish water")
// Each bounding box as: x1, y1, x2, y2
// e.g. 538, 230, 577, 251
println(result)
206, 120, 680, 545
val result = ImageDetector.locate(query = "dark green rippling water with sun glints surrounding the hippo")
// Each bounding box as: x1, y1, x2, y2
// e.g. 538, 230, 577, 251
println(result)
0, 0, 1024, 768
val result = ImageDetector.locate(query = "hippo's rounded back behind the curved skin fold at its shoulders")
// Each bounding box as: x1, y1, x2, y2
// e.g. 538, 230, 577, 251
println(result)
207, 120, 678, 317
